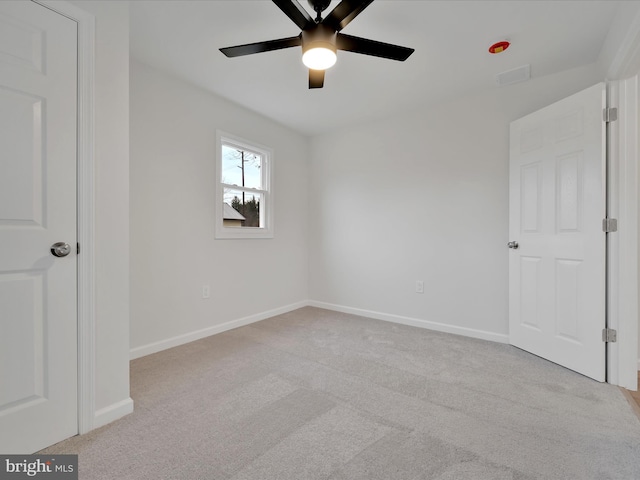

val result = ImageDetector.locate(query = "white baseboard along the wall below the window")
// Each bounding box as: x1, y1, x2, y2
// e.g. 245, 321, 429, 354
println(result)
129, 301, 309, 360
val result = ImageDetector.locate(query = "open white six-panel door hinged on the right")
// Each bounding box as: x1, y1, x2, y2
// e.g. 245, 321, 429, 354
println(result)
509, 84, 606, 381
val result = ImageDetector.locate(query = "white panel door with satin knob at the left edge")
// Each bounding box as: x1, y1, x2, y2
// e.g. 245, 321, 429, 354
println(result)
0, 1, 78, 454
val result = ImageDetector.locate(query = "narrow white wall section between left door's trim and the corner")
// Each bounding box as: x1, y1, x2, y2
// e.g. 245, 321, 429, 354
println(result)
71, 1, 132, 420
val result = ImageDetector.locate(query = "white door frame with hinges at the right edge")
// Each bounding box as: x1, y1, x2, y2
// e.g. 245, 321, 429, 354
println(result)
605, 6, 640, 390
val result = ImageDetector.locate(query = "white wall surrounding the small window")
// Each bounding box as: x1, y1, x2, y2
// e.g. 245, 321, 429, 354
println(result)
130, 60, 309, 357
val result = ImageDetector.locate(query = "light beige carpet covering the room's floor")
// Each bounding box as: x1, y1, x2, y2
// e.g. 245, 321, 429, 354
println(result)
44, 307, 640, 480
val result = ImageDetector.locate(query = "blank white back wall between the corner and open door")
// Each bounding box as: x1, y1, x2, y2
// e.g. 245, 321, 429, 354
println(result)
310, 65, 601, 341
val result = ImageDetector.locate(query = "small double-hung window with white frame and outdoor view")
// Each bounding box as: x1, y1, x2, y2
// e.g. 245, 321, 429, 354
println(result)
216, 132, 273, 238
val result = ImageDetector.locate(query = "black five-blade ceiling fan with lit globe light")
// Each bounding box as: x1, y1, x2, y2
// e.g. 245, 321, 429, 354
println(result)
220, 0, 414, 88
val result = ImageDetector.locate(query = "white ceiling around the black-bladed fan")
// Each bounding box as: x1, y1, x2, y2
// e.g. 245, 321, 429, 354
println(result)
130, 0, 620, 135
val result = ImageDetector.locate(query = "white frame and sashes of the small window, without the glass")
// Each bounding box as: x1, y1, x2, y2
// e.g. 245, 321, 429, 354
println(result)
215, 130, 274, 239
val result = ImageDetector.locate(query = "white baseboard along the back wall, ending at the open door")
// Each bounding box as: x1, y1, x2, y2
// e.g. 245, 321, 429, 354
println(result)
308, 300, 509, 343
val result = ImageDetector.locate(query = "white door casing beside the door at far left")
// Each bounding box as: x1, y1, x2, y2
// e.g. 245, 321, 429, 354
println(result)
32, 0, 96, 434
